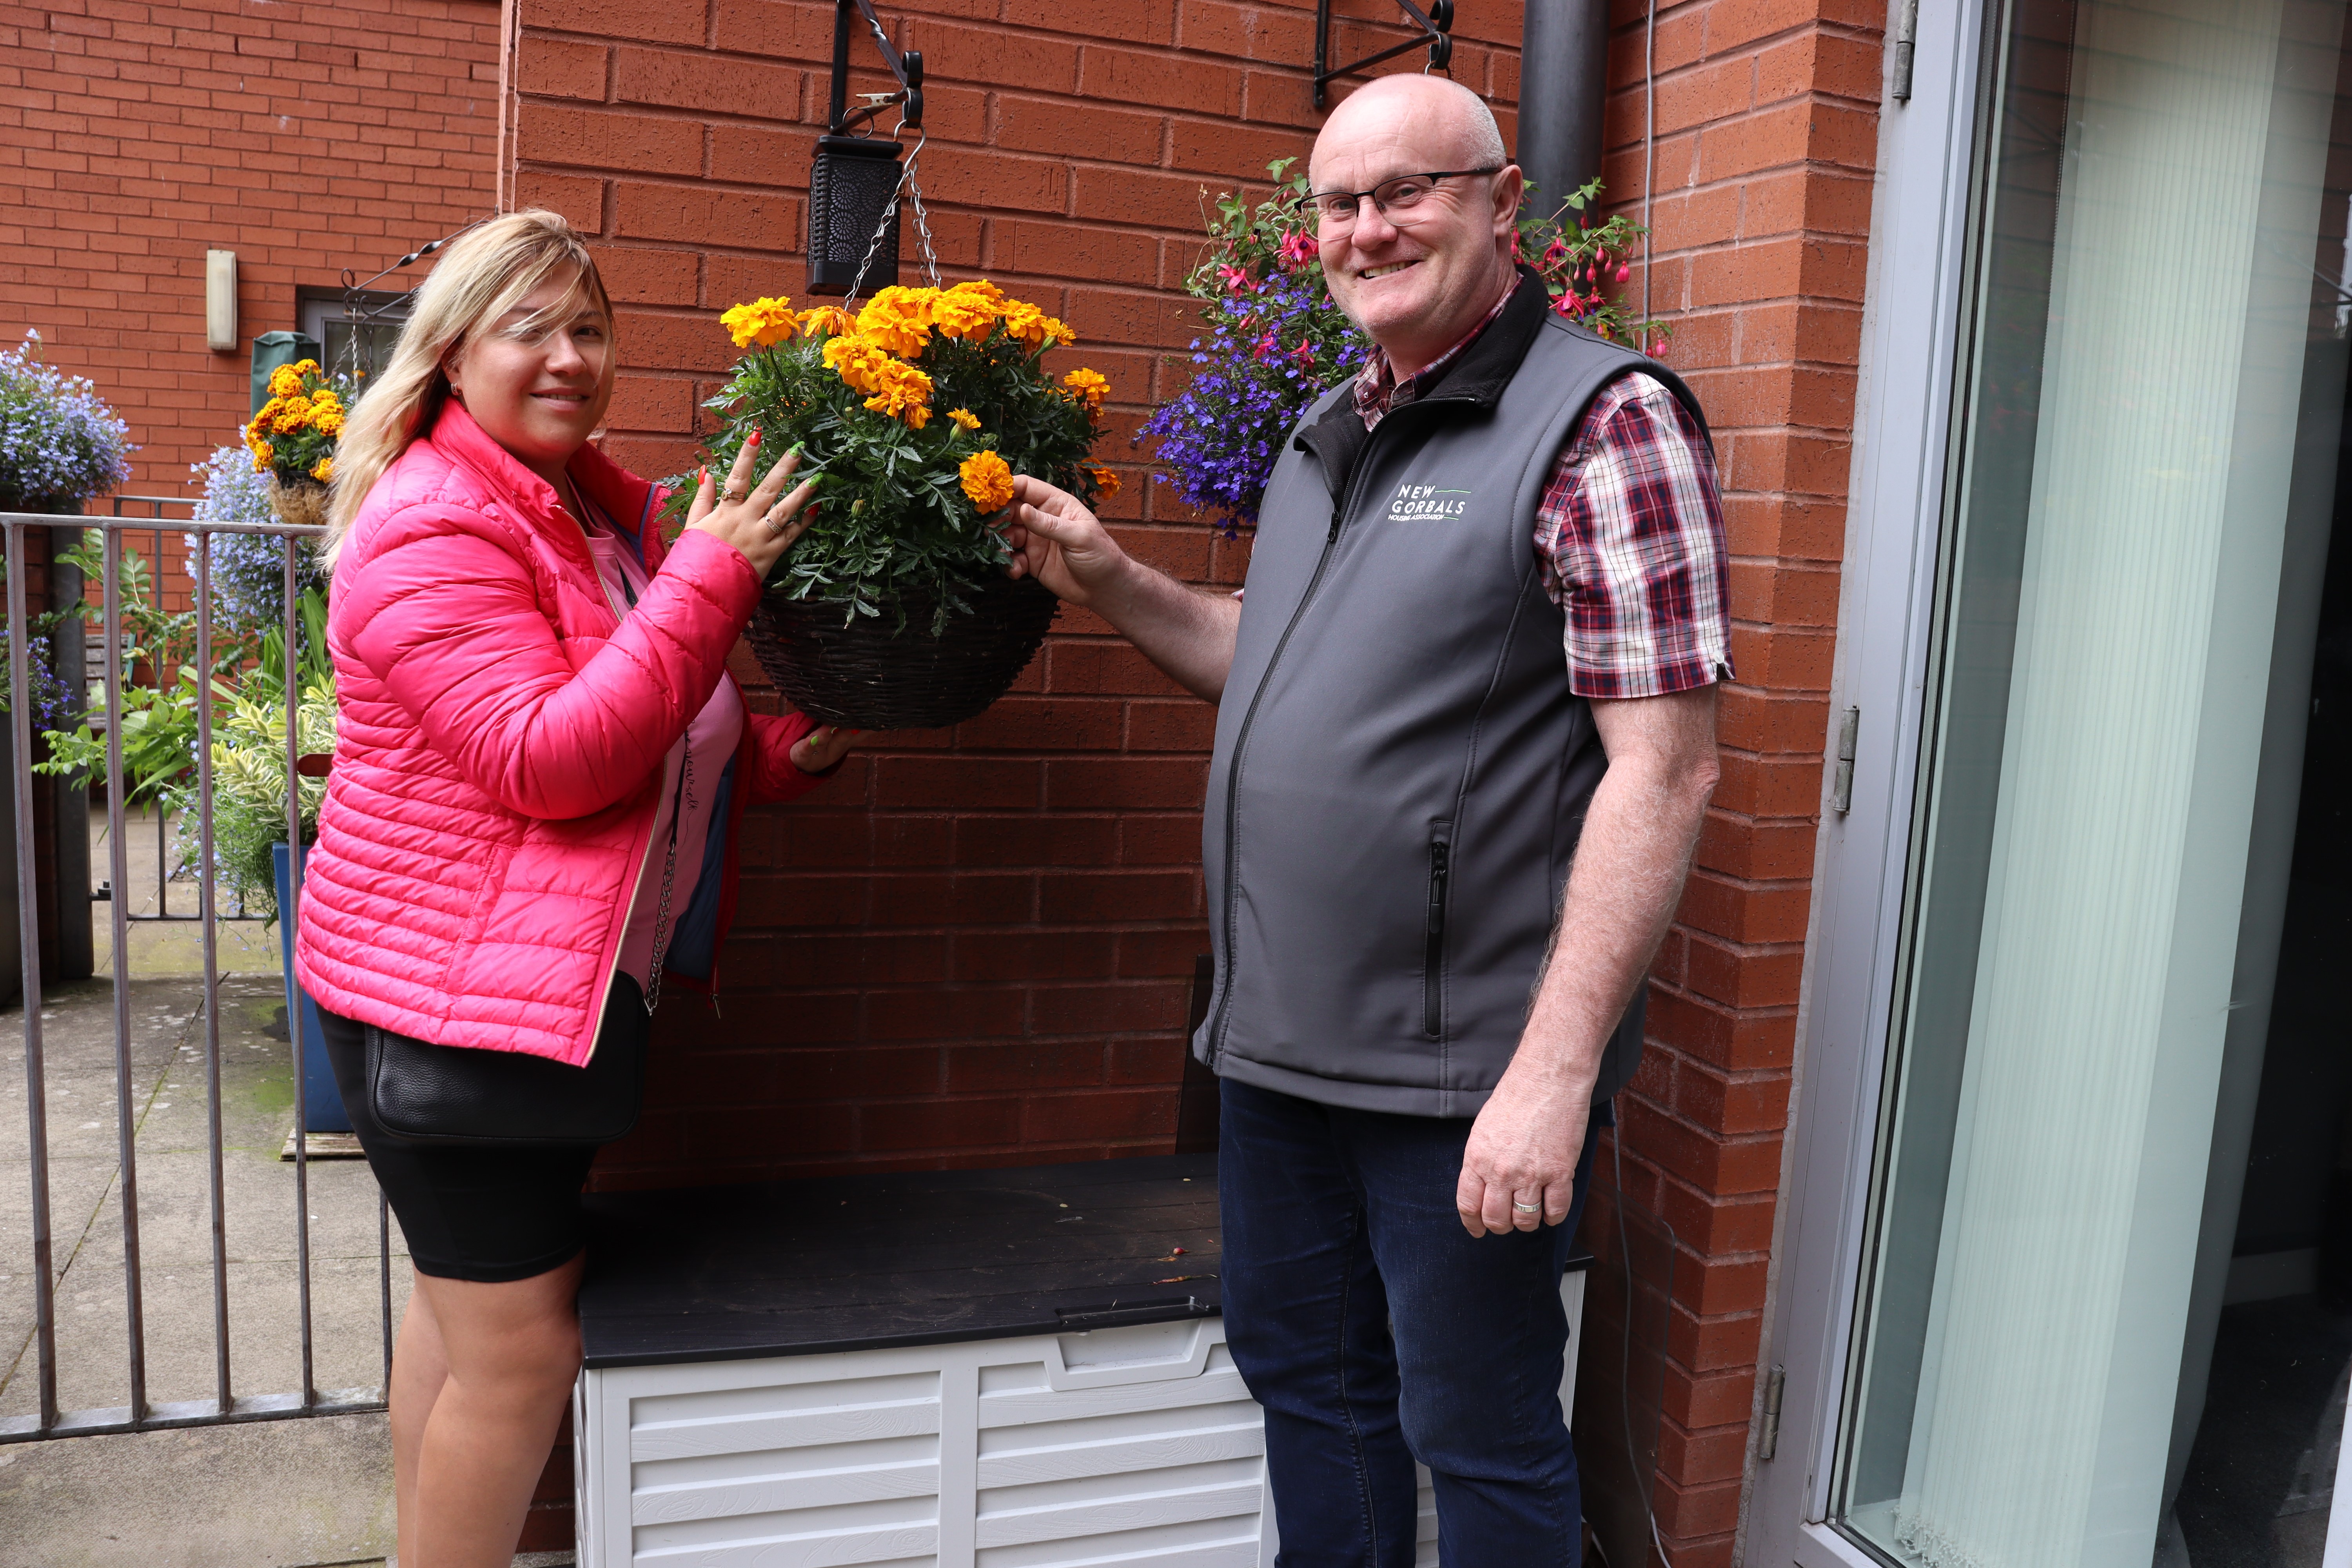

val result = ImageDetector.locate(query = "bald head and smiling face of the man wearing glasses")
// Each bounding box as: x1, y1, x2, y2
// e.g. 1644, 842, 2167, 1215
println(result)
1308, 75, 1524, 376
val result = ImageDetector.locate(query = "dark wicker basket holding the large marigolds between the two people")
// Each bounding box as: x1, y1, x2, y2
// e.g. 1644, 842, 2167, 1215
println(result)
746, 573, 1061, 729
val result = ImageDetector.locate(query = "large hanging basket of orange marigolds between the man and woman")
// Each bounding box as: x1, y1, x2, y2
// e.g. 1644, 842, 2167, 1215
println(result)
670, 280, 1120, 729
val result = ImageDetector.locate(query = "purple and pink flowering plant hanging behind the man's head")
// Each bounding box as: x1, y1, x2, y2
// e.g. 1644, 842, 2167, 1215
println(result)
1136, 158, 1663, 538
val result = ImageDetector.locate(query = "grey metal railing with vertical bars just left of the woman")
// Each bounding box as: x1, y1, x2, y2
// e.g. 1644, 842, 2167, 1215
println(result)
0, 510, 393, 1443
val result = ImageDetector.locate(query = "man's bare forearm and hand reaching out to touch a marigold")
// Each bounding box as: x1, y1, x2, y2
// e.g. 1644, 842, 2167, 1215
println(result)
997, 475, 1242, 703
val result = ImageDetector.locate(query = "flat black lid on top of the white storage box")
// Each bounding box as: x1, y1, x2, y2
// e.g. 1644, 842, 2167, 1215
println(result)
581, 1154, 1221, 1366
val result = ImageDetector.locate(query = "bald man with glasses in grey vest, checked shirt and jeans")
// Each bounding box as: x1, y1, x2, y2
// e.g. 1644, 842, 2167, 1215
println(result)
1007, 75, 1731, 1568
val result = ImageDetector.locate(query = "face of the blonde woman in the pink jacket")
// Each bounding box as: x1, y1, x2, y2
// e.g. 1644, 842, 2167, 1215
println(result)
445, 268, 614, 484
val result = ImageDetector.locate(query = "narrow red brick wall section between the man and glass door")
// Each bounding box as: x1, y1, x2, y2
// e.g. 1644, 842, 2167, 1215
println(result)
1585, 0, 1886, 1568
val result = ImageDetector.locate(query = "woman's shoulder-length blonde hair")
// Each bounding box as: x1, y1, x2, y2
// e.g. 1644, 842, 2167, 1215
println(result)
322, 209, 614, 566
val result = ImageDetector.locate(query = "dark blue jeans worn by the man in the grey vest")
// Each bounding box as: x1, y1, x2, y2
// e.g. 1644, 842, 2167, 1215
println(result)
1216, 1079, 1606, 1568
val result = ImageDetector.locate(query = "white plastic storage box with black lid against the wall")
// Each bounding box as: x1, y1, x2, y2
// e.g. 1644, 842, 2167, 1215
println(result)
574, 1154, 1585, 1568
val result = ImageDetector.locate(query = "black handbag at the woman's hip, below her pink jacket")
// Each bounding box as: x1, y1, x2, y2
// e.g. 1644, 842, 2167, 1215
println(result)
360, 976, 647, 1147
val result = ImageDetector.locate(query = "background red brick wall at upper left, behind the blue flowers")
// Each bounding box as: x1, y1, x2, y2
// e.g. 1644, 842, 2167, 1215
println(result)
0, 0, 499, 510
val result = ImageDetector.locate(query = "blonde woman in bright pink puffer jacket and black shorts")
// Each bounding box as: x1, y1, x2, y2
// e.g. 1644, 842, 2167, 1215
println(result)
294, 212, 849, 1568
